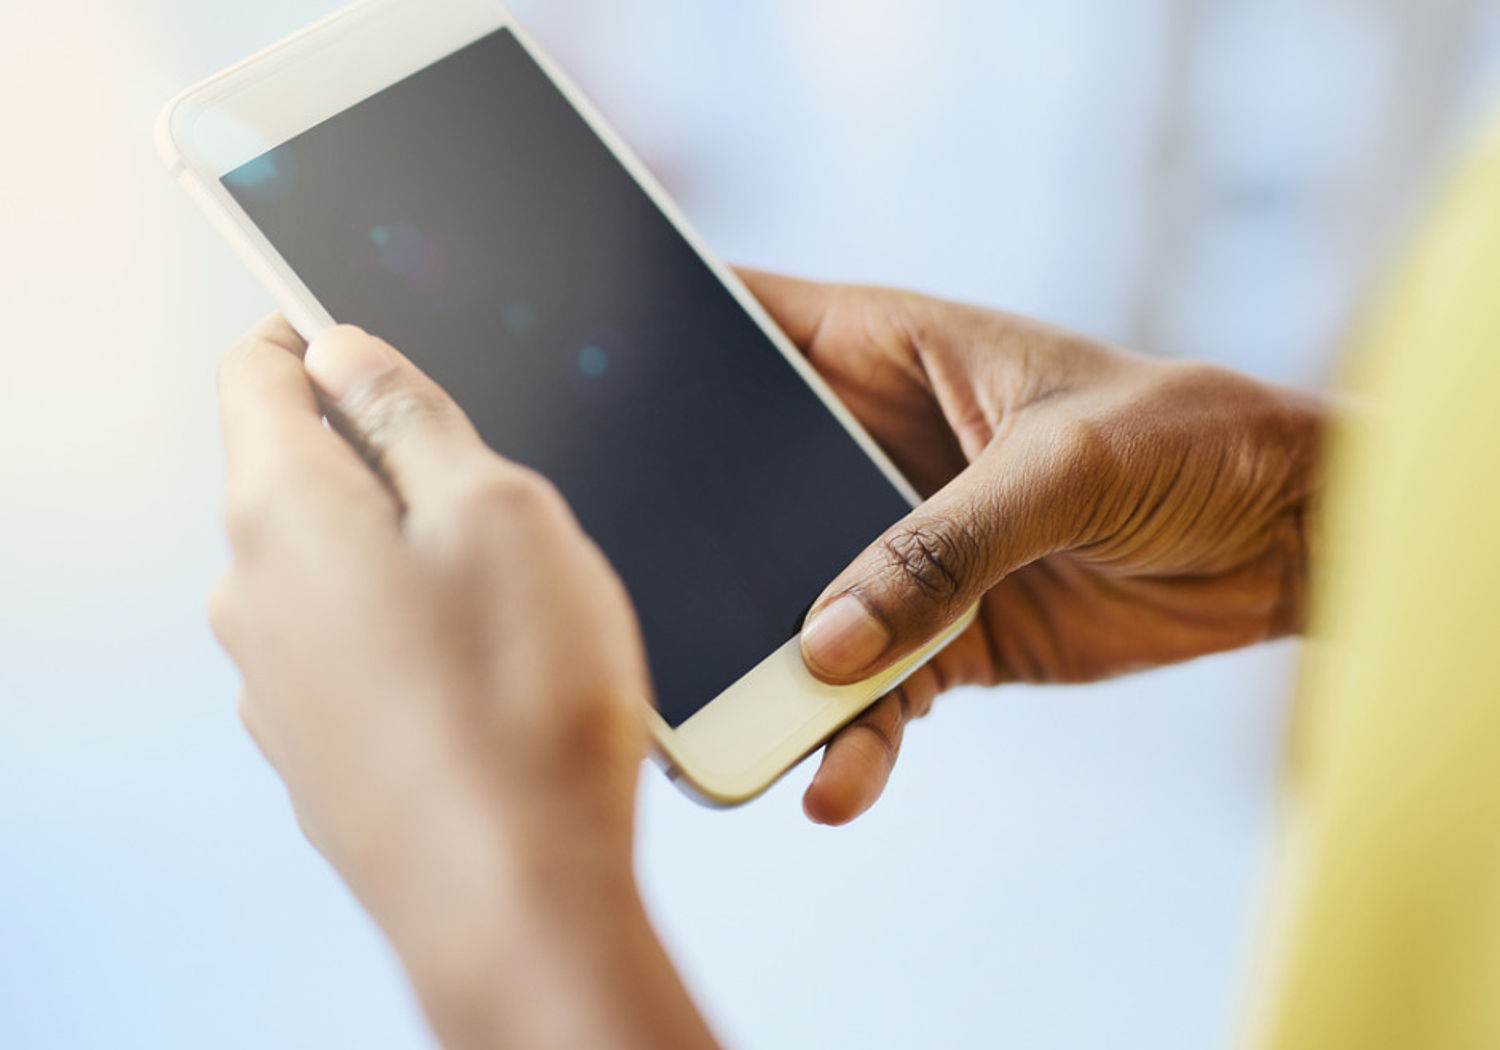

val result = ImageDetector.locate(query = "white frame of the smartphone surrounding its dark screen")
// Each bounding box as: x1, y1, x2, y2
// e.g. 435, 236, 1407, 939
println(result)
158, 0, 974, 806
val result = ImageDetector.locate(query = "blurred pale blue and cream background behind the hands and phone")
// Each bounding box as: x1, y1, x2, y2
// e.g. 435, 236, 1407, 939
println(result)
0, 0, 1500, 1050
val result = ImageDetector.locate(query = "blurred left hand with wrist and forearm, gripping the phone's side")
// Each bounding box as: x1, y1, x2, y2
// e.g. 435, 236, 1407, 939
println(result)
210, 318, 711, 1047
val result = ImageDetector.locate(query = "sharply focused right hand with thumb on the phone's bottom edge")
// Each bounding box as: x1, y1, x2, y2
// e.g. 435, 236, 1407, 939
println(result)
743, 272, 1323, 824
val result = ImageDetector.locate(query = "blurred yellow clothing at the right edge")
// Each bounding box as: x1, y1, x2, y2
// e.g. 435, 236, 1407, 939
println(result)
1257, 120, 1500, 1050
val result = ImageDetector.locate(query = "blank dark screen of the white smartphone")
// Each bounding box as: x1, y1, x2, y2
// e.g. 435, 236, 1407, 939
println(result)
224, 30, 908, 726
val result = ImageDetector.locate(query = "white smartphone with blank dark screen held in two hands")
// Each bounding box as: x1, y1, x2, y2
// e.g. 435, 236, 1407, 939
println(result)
158, 0, 968, 804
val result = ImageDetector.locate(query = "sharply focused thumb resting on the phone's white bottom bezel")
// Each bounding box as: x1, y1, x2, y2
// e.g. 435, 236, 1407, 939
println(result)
801, 434, 1086, 683
